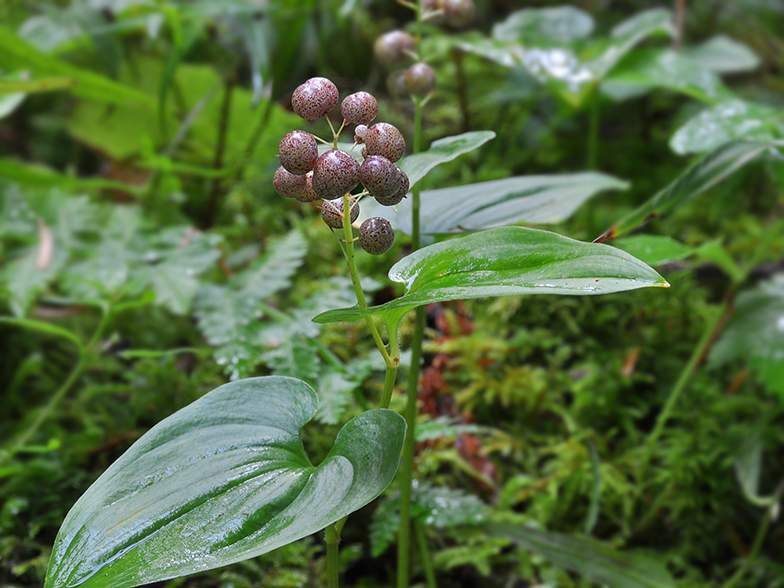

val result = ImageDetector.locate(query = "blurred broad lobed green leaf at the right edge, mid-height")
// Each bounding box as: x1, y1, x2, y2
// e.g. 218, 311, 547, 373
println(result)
708, 275, 784, 398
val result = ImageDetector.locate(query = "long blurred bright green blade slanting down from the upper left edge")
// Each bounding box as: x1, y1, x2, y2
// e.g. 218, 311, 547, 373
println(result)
0, 27, 152, 107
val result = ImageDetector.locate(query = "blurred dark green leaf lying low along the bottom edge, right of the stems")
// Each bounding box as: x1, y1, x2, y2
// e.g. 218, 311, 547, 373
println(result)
485, 523, 675, 588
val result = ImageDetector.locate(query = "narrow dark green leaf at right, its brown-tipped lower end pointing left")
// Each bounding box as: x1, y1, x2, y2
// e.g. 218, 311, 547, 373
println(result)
595, 141, 775, 243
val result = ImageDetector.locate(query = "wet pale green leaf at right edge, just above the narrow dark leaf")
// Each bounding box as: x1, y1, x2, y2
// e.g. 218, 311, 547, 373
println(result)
670, 99, 784, 155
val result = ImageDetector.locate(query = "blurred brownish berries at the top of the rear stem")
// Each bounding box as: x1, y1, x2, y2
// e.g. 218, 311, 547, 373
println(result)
373, 0, 475, 98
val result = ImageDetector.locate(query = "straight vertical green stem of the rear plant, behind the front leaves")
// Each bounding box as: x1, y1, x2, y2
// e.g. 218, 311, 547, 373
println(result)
397, 92, 425, 588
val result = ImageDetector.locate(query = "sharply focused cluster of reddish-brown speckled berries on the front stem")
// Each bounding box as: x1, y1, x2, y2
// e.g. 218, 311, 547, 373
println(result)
272, 78, 409, 255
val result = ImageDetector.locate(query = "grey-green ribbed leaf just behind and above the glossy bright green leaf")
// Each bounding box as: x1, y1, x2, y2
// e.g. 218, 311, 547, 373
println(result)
375, 172, 629, 234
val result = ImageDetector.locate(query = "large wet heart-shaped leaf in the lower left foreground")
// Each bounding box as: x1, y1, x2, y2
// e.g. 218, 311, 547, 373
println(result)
46, 377, 405, 588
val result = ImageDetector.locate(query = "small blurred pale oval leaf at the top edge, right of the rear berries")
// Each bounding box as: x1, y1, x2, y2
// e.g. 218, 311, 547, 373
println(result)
493, 6, 593, 45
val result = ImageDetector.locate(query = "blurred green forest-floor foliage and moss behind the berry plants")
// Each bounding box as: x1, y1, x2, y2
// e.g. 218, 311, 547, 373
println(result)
0, 0, 784, 588
